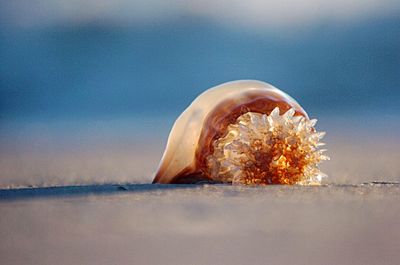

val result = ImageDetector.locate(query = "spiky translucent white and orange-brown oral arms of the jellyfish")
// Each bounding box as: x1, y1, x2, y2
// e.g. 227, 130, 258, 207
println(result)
207, 108, 329, 185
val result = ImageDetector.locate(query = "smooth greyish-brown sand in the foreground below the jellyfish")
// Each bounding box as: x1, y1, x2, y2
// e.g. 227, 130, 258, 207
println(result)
0, 184, 400, 264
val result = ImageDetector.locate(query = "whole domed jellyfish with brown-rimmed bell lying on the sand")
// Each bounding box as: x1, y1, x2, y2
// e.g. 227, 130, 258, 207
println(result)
153, 80, 329, 185
